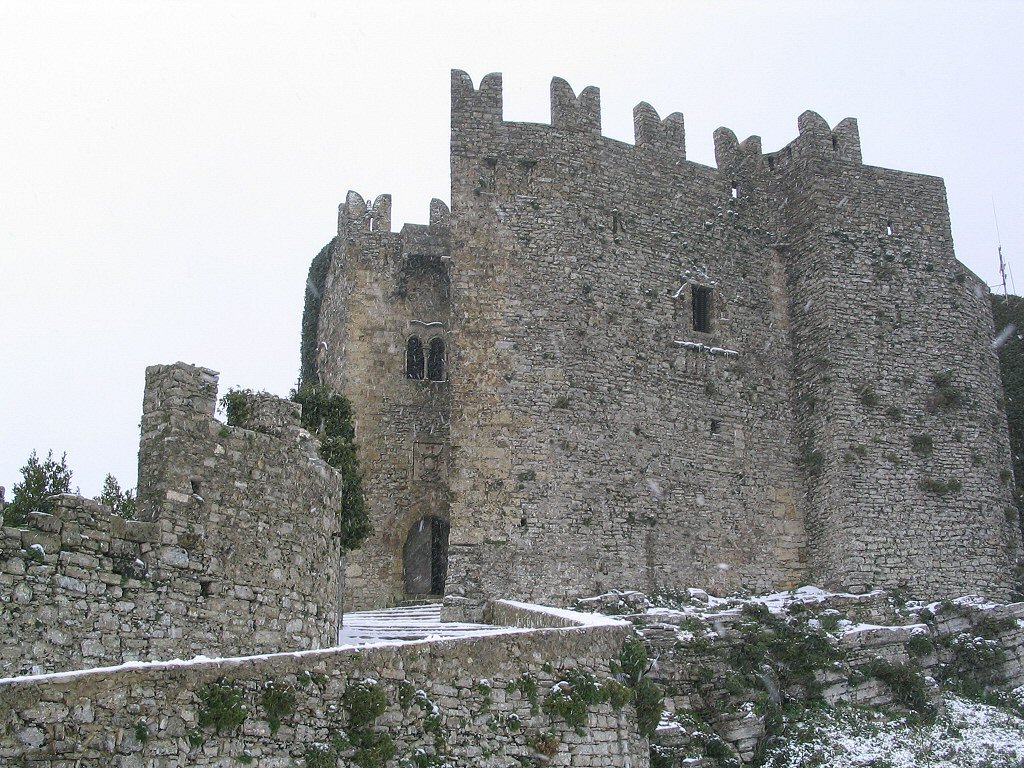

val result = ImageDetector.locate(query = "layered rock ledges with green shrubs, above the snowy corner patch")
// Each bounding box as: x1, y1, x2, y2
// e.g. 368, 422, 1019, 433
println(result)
626, 591, 1024, 765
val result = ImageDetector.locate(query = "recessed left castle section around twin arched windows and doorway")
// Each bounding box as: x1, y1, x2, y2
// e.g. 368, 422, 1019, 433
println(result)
317, 193, 451, 609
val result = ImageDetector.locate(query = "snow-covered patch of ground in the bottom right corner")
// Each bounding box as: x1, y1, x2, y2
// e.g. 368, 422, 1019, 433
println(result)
764, 689, 1024, 768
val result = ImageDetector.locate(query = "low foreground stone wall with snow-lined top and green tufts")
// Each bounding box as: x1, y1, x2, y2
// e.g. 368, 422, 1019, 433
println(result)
0, 609, 648, 768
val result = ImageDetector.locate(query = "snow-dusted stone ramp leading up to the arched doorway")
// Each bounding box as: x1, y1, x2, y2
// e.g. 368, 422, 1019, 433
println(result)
338, 603, 523, 645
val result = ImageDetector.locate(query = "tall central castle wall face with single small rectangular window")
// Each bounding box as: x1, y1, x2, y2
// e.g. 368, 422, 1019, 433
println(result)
450, 73, 806, 618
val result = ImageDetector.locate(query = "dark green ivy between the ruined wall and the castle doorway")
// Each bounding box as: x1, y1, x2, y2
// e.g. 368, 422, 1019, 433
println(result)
292, 384, 373, 550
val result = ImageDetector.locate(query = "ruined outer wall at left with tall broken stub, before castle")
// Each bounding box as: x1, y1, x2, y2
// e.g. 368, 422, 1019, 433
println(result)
0, 364, 340, 675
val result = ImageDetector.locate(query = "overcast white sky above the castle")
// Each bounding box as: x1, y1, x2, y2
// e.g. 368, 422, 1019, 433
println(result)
0, 0, 1024, 499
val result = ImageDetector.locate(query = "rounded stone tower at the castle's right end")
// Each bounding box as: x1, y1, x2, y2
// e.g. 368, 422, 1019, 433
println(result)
745, 113, 1020, 599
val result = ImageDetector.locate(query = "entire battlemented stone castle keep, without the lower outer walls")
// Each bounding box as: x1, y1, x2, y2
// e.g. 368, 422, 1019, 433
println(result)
313, 71, 1020, 614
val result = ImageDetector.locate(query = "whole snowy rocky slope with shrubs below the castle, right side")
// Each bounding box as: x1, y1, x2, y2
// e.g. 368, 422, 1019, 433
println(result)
578, 587, 1024, 768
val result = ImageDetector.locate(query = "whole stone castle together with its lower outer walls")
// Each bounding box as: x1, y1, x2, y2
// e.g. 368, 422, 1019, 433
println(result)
0, 72, 1024, 768
